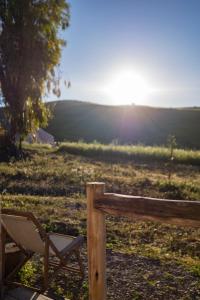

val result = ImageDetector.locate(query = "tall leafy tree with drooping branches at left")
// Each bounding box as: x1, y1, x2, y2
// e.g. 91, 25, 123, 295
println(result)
0, 0, 69, 150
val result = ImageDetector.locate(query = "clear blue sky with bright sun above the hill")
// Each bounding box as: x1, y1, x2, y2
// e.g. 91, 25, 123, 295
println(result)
49, 0, 200, 107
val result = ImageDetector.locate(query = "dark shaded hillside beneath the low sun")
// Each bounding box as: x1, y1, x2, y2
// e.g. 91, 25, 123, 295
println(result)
47, 101, 200, 149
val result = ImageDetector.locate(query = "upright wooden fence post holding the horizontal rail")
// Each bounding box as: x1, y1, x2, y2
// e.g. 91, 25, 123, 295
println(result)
87, 182, 106, 300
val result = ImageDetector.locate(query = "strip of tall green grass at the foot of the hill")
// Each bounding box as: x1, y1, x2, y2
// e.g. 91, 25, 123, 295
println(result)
59, 142, 200, 166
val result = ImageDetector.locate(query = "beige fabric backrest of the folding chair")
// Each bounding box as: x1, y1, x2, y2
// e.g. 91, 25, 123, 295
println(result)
0, 213, 44, 254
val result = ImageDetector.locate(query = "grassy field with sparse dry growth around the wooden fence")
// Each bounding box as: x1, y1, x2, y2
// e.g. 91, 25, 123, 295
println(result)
0, 144, 200, 300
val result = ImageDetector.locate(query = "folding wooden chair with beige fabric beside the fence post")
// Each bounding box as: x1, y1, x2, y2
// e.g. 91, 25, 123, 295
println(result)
1, 209, 84, 292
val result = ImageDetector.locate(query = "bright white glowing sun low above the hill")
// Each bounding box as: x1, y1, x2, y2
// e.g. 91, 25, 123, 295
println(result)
105, 70, 153, 105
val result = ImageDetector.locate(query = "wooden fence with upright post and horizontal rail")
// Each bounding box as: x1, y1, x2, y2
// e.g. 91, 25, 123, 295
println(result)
87, 182, 200, 300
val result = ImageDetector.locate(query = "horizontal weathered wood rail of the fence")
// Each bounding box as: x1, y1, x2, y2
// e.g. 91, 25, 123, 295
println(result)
94, 193, 200, 227
